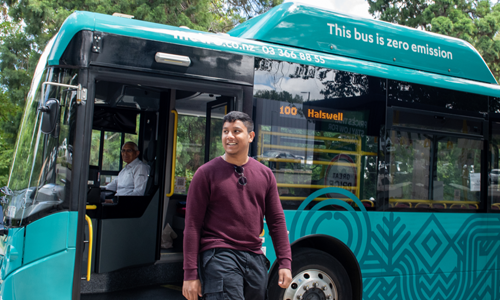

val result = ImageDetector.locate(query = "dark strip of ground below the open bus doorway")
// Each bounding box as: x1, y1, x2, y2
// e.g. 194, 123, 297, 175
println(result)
81, 285, 186, 300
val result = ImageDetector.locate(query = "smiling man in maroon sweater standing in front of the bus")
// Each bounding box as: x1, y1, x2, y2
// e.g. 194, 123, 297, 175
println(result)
182, 112, 292, 300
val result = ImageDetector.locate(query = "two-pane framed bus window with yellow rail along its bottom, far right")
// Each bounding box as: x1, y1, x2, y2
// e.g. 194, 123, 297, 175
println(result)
387, 131, 482, 210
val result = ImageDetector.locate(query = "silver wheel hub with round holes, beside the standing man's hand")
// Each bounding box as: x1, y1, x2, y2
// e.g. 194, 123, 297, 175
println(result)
283, 269, 338, 300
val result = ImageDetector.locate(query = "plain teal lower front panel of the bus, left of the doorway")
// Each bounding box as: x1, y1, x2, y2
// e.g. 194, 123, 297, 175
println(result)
0, 212, 78, 300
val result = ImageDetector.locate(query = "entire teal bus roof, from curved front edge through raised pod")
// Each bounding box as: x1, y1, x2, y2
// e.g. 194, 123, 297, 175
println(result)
48, 3, 500, 97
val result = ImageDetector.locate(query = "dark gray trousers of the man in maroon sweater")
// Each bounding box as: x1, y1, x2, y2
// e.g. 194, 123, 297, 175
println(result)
198, 248, 269, 300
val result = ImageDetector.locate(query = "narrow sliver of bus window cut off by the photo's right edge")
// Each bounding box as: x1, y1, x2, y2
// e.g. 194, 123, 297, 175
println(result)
488, 121, 500, 212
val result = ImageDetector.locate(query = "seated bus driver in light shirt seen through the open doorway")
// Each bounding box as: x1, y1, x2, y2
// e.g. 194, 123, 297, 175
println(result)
105, 142, 149, 196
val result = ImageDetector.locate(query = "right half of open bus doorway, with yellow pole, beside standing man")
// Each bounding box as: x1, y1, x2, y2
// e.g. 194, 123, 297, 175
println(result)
160, 93, 235, 261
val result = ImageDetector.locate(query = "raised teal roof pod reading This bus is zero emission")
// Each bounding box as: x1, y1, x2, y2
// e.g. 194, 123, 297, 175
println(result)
229, 2, 497, 83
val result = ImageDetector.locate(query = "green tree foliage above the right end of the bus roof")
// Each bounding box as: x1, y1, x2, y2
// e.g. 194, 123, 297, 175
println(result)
367, 0, 500, 81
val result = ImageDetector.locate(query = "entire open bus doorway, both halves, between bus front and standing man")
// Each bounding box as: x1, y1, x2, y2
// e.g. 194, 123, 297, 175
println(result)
82, 77, 243, 282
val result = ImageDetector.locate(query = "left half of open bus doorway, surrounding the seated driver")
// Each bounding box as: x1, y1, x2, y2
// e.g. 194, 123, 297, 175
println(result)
82, 79, 170, 273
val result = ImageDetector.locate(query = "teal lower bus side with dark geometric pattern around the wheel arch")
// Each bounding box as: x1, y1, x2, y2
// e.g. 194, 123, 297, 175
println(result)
263, 188, 500, 300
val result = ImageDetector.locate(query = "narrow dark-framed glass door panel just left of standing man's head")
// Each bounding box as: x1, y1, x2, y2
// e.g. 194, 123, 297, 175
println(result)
205, 97, 233, 161
